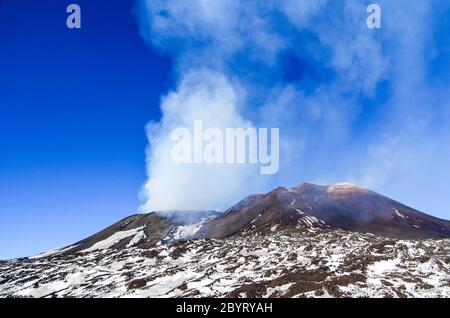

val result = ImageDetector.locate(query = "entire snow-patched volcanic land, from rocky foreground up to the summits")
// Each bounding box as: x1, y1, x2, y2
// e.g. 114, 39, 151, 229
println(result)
0, 184, 450, 298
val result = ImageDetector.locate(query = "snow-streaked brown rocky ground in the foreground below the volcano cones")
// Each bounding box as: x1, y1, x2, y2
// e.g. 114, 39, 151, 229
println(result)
0, 225, 450, 297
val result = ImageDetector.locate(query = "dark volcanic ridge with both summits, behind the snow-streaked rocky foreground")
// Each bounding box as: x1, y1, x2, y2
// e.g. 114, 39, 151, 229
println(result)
8, 183, 450, 257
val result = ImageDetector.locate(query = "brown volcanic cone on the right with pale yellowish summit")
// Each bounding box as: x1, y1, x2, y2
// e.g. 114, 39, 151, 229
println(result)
197, 183, 450, 239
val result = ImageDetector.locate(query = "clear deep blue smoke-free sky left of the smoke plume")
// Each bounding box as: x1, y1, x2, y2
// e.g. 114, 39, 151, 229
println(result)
0, 0, 171, 259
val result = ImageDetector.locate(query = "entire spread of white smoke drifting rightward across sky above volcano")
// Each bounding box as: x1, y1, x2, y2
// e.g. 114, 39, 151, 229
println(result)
138, 0, 449, 219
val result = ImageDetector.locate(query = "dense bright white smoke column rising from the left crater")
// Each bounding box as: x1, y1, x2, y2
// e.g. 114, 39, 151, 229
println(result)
143, 70, 255, 211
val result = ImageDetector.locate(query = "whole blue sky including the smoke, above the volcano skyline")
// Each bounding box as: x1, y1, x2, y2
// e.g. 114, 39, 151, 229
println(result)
0, 0, 450, 259
